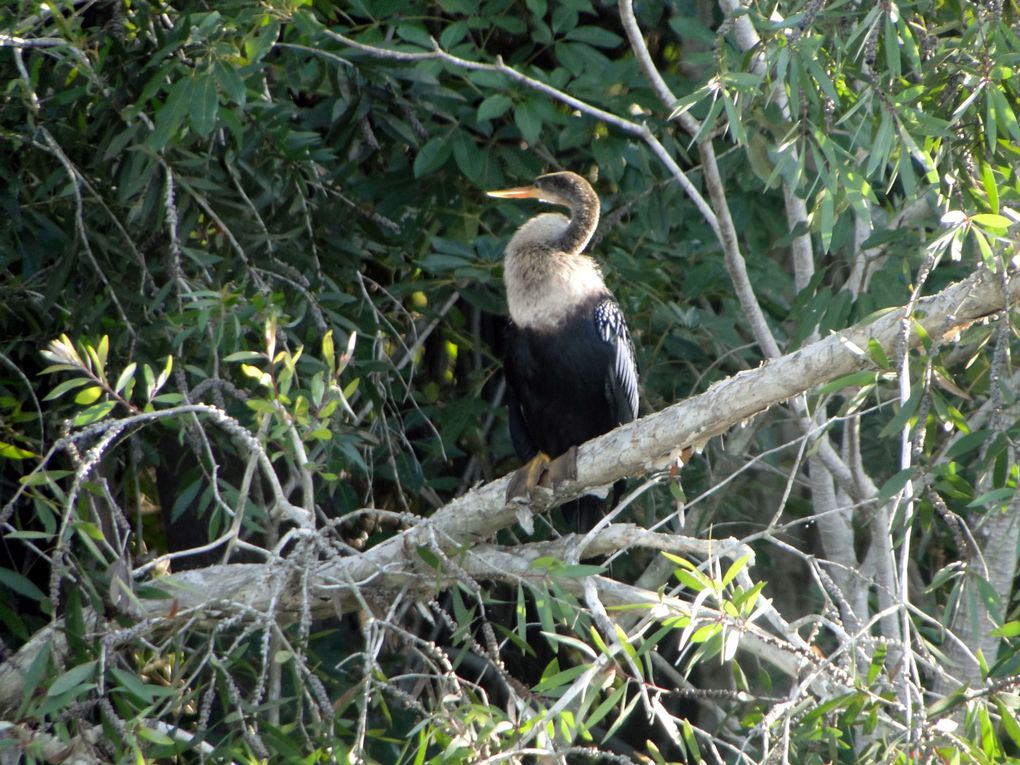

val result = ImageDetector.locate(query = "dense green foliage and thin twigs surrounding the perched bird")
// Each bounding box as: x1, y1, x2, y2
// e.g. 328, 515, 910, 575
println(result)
0, 0, 1020, 763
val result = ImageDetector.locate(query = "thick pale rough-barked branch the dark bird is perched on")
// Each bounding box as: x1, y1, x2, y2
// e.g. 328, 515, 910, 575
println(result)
0, 268, 1020, 711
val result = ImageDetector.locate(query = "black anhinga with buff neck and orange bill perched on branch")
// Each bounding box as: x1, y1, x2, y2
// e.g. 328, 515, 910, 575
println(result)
489, 172, 638, 531
